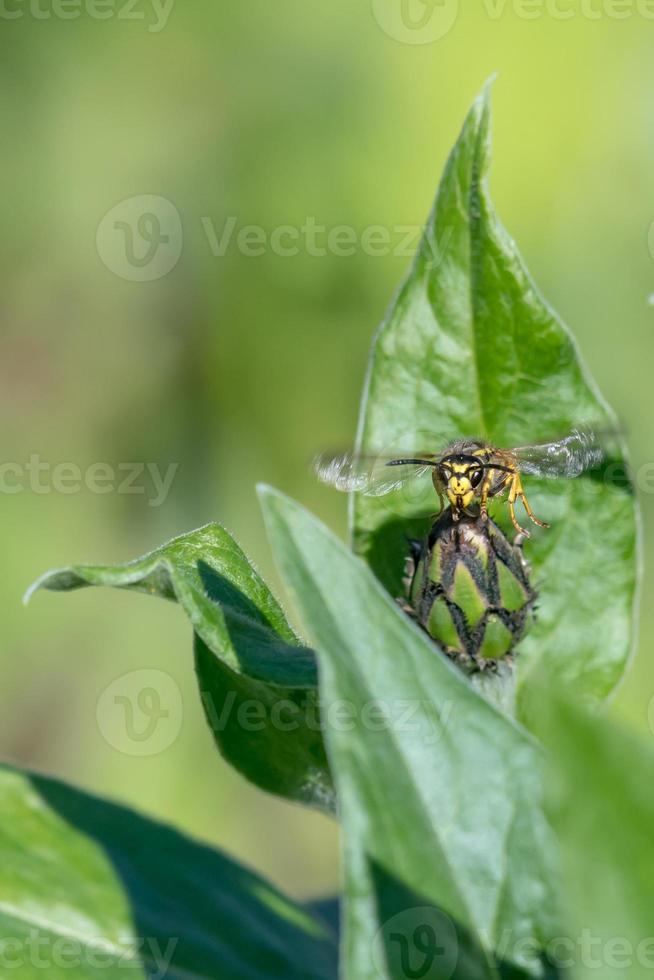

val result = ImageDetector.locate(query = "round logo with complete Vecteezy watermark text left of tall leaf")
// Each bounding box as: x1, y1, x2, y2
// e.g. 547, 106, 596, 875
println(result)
97, 193, 453, 282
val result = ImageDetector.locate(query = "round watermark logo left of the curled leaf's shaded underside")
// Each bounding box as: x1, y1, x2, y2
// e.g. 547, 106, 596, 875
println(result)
95, 669, 184, 756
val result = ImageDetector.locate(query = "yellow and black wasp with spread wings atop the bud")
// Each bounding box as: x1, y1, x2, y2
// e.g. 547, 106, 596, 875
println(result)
314, 429, 604, 537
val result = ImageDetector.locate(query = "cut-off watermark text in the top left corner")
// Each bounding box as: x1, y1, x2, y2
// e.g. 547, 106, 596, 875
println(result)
0, 0, 175, 34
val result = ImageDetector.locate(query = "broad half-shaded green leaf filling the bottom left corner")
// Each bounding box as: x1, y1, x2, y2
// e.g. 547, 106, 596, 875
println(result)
0, 767, 336, 980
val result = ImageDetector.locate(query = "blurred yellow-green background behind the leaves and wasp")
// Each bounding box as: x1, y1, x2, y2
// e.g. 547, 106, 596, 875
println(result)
0, 0, 654, 896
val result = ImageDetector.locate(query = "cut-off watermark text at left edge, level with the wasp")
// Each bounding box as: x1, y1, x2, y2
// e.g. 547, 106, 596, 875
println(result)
0, 453, 179, 507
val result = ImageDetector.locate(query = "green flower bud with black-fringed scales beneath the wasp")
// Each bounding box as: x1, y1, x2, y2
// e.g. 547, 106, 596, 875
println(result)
405, 508, 536, 670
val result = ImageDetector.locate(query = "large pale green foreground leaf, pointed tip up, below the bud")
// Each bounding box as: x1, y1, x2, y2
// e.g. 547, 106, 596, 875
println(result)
261, 488, 556, 980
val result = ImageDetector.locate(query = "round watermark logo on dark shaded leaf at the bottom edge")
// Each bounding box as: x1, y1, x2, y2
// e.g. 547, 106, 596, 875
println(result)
372, 905, 459, 980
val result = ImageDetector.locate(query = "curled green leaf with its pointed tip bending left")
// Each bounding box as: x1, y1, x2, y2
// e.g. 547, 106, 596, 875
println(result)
28, 524, 334, 810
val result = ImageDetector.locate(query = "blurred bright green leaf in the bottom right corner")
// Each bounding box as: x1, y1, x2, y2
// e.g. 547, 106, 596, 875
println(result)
547, 704, 654, 980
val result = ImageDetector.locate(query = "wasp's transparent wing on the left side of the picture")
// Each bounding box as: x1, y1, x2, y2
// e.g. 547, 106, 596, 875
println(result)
313, 452, 436, 497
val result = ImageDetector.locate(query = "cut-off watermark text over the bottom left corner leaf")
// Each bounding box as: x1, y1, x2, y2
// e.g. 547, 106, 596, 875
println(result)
0, 929, 179, 980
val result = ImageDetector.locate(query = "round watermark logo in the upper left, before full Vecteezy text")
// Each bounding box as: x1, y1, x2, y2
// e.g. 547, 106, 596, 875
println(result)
96, 194, 184, 282
